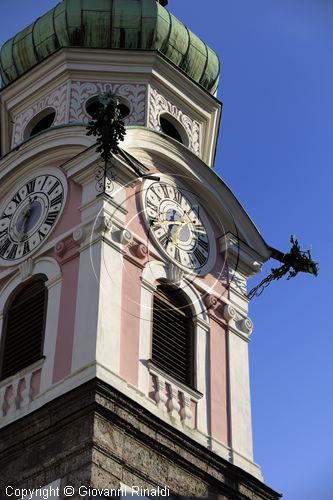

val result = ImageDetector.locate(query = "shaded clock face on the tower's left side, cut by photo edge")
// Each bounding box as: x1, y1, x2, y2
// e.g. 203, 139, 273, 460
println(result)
0, 170, 67, 265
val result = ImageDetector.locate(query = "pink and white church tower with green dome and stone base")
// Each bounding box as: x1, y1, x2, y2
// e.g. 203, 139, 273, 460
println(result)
0, 0, 279, 500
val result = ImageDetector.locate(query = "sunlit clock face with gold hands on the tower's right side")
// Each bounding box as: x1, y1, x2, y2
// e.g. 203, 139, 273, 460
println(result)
143, 180, 216, 274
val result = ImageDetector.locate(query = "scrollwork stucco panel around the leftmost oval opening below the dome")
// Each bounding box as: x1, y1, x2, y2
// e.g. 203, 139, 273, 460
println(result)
12, 84, 67, 147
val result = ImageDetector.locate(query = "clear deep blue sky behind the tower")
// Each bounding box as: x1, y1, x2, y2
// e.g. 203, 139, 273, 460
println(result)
0, 0, 333, 500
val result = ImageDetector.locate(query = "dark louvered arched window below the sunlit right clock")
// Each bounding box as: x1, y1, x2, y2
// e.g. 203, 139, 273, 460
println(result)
152, 284, 194, 387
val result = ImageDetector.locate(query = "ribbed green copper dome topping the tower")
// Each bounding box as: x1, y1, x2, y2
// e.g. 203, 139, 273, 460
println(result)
0, 0, 220, 93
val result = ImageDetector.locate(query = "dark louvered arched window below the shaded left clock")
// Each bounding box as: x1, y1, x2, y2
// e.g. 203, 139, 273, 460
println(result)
1, 277, 47, 379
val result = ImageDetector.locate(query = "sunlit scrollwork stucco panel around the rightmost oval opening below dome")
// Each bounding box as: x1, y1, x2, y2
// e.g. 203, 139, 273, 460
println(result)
149, 88, 200, 156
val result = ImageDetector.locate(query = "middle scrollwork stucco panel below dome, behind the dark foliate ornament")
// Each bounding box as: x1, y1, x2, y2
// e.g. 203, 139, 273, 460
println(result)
69, 81, 146, 125
